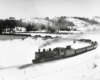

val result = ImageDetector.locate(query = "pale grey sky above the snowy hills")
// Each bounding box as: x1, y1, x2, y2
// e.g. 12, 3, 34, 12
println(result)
0, 0, 100, 19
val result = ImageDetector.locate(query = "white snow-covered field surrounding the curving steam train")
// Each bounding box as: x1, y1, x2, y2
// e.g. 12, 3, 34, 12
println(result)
0, 31, 100, 80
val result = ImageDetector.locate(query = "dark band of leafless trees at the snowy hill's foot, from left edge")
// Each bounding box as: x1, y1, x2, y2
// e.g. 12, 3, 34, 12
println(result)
0, 16, 74, 34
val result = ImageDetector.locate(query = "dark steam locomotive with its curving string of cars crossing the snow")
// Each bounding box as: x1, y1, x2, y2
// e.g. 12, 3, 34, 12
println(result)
32, 39, 98, 63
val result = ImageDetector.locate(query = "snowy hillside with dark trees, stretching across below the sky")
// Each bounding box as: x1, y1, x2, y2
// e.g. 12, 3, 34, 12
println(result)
0, 16, 100, 33
